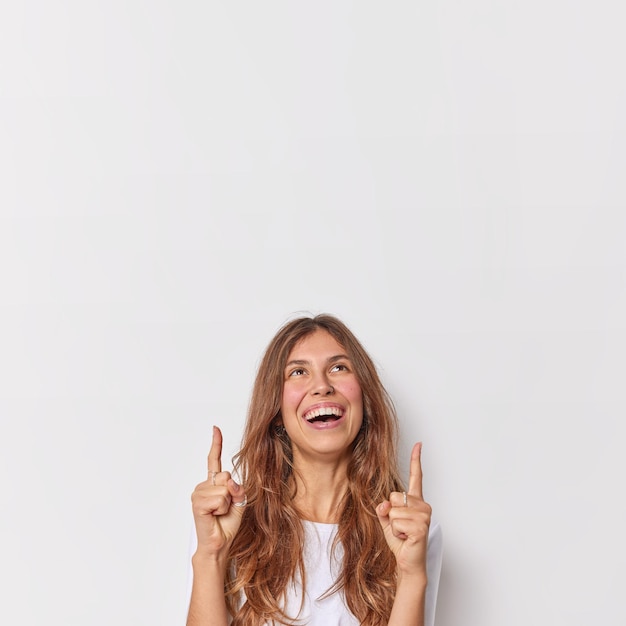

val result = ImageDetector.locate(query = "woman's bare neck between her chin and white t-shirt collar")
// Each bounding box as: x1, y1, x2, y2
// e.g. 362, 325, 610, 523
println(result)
293, 454, 348, 524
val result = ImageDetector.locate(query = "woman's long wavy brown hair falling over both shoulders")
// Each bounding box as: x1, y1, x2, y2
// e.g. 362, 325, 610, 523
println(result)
226, 314, 403, 626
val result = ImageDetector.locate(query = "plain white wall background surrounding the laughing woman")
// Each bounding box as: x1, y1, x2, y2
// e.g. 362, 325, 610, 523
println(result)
0, 0, 626, 626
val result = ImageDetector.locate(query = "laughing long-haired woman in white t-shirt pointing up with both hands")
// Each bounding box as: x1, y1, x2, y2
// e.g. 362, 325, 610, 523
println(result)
187, 315, 441, 626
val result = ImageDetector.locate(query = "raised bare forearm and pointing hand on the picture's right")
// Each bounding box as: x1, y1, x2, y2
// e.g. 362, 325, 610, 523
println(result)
376, 443, 431, 626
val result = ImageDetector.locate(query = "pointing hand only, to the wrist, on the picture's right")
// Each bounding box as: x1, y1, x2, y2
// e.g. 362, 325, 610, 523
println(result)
376, 443, 431, 578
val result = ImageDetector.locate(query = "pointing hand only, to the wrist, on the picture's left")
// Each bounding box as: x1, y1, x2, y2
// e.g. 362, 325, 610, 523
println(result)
191, 426, 246, 562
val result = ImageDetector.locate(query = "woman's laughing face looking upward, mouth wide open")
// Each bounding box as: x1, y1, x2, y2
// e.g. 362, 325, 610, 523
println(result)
281, 330, 363, 462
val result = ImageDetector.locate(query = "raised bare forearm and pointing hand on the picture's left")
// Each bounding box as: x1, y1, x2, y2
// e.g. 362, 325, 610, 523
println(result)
187, 426, 246, 626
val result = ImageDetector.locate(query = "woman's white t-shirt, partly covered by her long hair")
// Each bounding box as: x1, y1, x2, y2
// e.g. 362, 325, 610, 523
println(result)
189, 520, 443, 626
